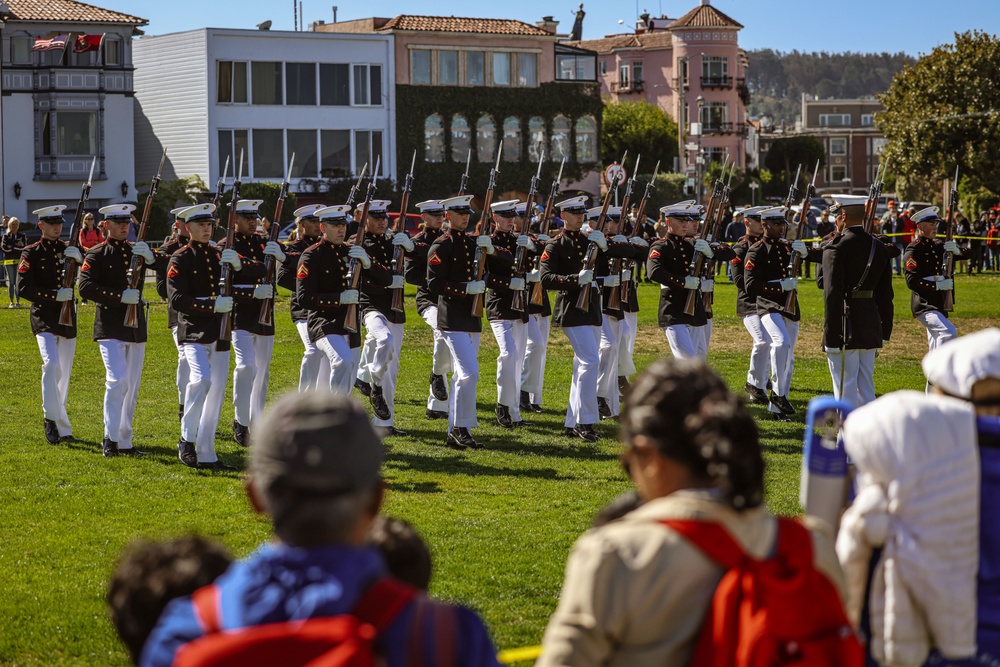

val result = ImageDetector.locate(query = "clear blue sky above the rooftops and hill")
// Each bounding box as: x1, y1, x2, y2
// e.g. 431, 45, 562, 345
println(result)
127, 0, 1000, 56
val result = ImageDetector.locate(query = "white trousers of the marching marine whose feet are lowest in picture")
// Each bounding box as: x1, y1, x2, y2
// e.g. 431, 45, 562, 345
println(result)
181, 343, 229, 463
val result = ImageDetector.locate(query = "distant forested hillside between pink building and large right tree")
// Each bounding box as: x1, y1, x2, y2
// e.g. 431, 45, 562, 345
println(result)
746, 49, 915, 125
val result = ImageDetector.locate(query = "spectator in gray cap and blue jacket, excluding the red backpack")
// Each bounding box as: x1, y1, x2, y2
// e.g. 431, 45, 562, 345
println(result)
140, 391, 497, 667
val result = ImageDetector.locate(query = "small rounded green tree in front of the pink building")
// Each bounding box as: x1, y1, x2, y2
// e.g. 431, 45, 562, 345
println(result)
601, 101, 677, 171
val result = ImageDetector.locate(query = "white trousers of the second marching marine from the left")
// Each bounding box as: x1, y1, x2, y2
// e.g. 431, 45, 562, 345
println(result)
97, 339, 146, 449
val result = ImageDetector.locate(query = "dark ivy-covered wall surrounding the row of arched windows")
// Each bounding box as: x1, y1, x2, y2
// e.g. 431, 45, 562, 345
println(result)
396, 82, 604, 202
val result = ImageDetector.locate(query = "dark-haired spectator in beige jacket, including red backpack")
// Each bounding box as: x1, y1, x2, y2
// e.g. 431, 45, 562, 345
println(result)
536, 360, 864, 667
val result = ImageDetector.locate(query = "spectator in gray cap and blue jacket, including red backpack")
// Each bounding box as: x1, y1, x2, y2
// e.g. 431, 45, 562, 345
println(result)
140, 392, 497, 667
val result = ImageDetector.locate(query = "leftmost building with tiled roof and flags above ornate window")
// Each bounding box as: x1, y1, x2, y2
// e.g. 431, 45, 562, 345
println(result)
0, 0, 146, 225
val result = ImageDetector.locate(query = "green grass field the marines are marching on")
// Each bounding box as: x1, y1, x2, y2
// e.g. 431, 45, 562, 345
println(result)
0, 275, 1000, 665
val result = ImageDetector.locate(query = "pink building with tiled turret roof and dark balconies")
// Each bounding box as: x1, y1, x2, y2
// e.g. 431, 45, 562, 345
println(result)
570, 0, 750, 177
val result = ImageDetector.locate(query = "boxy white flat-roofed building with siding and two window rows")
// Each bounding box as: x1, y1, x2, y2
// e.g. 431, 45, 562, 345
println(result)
135, 28, 396, 191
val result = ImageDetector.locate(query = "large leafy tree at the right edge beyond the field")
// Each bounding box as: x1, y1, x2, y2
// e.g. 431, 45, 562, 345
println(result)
875, 30, 1000, 206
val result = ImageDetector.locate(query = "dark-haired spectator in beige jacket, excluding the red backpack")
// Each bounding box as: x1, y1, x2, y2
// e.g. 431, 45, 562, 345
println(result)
536, 359, 843, 667
